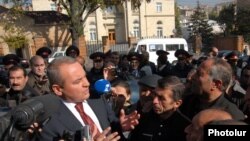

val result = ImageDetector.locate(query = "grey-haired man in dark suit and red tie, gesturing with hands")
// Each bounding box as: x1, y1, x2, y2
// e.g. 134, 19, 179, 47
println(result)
38, 57, 139, 141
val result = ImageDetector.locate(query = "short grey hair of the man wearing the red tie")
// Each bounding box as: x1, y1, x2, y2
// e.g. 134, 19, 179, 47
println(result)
47, 56, 77, 86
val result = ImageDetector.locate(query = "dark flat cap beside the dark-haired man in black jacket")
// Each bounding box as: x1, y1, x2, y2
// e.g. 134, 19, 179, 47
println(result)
138, 74, 162, 88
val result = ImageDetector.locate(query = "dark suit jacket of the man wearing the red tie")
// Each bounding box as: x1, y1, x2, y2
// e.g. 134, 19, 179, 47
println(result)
37, 97, 122, 141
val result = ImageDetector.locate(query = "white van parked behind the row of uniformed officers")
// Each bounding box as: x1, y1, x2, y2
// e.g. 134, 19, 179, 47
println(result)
135, 38, 188, 65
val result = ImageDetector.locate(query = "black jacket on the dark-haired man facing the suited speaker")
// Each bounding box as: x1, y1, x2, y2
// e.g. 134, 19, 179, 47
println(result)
129, 110, 191, 141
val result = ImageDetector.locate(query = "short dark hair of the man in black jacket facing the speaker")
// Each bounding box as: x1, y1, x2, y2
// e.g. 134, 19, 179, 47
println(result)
157, 76, 185, 101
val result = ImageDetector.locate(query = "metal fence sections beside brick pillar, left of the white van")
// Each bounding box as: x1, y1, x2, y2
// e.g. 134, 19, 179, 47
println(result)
86, 41, 129, 56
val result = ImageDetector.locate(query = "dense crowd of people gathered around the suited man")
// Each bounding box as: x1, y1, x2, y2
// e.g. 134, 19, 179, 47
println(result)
0, 46, 250, 141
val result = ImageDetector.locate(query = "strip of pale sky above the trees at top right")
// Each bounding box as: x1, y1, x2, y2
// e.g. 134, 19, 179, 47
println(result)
176, 0, 233, 7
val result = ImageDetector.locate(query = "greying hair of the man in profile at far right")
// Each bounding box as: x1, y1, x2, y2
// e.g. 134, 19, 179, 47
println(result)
209, 58, 233, 91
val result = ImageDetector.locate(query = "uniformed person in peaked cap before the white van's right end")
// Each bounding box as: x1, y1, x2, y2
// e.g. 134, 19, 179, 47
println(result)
172, 49, 193, 79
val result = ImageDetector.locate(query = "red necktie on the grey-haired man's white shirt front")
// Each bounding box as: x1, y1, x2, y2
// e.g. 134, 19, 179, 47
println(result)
75, 102, 100, 135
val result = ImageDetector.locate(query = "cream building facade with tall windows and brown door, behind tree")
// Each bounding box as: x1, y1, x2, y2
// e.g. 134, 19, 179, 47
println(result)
32, 0, 175, 43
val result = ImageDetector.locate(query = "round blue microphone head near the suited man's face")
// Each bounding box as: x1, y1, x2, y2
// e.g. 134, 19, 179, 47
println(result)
94, 79, 111, 94
